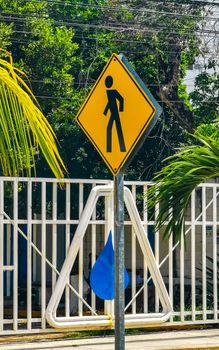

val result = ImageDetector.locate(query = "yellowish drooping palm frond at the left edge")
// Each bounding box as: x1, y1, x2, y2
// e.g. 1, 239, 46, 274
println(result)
0, 52, 65, 178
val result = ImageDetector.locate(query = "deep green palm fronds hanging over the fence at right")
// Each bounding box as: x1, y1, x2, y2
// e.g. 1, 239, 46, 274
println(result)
148, 133, 219, 241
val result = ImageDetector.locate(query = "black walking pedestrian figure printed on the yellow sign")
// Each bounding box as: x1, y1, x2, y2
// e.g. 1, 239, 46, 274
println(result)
103, 75, 126, 152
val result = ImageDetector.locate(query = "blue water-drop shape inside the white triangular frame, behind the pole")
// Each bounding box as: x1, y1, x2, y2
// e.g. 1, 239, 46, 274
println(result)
90, 231, 129, 300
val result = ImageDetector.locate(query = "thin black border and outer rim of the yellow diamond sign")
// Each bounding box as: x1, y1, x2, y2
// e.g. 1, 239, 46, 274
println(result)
75, 54, 156, 176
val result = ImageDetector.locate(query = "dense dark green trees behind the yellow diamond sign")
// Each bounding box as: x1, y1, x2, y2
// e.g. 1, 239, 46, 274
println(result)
0, 0, 216, 179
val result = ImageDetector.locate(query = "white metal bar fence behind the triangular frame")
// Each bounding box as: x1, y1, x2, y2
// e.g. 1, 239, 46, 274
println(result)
0, 177, 219, 334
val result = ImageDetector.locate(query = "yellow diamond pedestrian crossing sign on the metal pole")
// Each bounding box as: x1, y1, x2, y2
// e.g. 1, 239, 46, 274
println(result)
76, 54, 160, 175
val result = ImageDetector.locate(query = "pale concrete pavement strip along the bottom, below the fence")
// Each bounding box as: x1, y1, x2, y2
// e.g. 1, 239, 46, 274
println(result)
0, 329, 219, 350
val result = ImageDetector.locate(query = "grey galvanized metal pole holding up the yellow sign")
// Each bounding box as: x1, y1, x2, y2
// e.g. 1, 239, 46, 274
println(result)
114, 171, 125, 350
